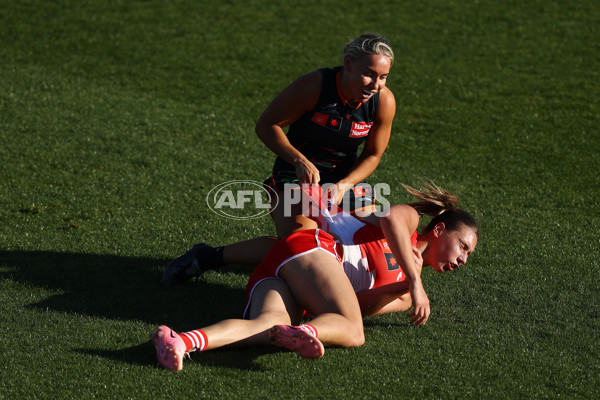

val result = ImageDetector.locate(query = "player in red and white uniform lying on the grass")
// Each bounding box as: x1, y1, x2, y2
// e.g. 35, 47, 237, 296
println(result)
152, 186, 478, 370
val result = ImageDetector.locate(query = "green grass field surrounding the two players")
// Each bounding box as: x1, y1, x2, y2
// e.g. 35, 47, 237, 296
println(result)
0, 0, 600, 399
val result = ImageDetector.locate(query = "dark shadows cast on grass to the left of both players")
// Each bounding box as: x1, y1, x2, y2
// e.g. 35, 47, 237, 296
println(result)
0, 251, 268, 370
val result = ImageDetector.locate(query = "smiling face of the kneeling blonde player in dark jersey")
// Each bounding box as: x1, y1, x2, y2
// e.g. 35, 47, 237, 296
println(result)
344, 54, 391, 103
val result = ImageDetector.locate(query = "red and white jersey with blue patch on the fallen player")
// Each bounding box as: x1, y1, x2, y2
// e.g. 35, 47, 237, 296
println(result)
313, 186, 417, 293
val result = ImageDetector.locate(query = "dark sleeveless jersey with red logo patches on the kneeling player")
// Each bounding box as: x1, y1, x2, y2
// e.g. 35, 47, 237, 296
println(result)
273, 67, 379, 184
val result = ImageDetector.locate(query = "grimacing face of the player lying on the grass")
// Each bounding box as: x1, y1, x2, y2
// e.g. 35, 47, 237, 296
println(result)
432, 224, 477, 274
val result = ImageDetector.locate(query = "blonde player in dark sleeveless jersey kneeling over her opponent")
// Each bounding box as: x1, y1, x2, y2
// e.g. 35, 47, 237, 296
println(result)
163, 34, 396, 284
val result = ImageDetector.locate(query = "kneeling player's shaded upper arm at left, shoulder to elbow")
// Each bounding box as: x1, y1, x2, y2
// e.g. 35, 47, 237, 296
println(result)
256, 71, 322, 131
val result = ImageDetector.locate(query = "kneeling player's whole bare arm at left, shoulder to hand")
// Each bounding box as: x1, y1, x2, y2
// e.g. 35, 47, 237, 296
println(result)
255, 71, 322, 183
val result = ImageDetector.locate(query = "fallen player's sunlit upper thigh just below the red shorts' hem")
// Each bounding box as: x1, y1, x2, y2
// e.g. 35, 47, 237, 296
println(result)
278, 250, 362, 322
